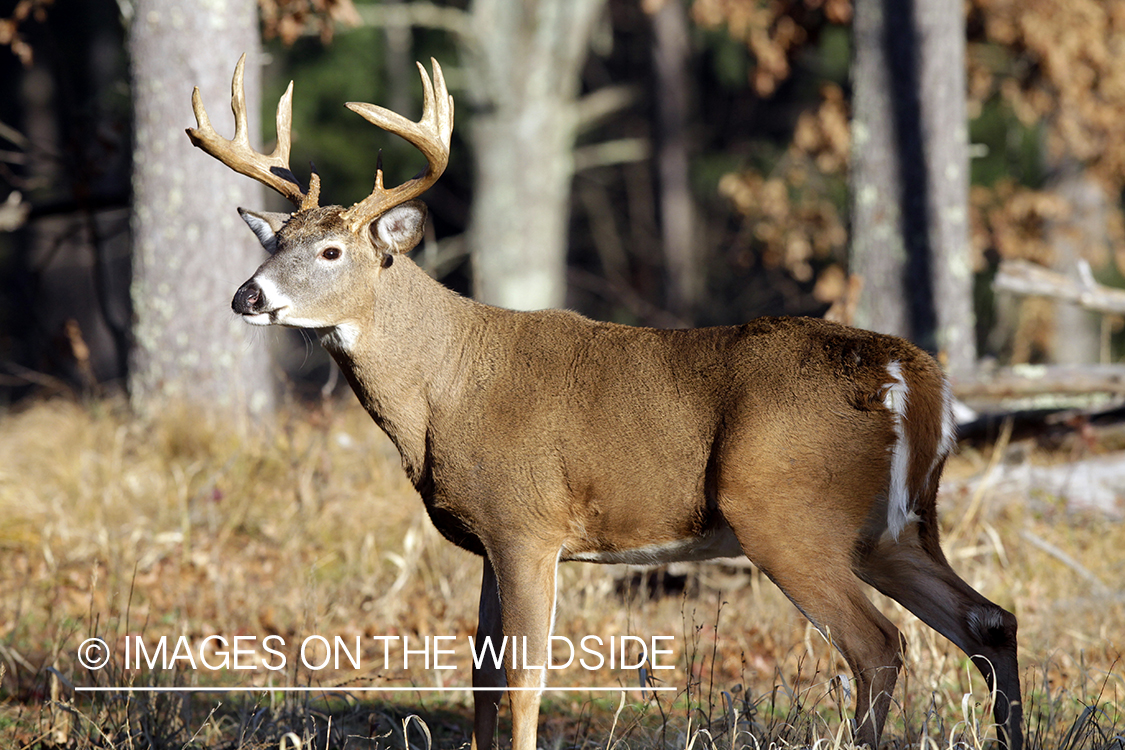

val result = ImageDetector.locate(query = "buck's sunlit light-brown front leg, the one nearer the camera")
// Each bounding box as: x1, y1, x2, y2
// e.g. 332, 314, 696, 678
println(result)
489, 548, 559, 750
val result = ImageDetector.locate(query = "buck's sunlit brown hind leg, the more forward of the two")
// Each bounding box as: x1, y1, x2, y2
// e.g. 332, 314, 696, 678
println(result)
723, 498, 902, 747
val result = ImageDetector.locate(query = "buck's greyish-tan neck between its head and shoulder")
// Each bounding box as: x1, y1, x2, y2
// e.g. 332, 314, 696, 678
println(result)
321, 257, 487, 489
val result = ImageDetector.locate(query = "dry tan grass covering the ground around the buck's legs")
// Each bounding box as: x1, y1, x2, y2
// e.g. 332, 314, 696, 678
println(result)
0, 399, 1125, 749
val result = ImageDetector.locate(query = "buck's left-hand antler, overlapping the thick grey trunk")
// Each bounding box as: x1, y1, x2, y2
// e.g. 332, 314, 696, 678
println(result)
188, 54, 321, 210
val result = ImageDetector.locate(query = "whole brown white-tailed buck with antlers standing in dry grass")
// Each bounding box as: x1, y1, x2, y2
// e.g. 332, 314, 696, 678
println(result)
188, 61, 1022, 750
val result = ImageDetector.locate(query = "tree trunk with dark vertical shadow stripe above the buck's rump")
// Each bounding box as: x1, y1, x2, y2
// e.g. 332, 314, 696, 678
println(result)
852, 0, 977, 370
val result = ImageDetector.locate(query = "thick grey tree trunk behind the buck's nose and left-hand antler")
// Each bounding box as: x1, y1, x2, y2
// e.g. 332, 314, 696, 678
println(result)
129, 0, 273, 425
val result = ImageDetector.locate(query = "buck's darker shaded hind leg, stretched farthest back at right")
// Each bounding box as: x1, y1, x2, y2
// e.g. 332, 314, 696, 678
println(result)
856, 522, 1023, 750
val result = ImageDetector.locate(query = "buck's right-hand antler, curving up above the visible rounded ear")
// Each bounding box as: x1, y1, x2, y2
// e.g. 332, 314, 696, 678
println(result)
342, 57, 453, 232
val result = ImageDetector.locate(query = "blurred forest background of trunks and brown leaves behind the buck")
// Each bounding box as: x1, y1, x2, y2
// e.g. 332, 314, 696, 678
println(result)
0, 0, 1125, 410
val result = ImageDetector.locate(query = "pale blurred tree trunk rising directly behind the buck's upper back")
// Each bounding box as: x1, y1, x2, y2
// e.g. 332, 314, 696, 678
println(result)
466, 0, 605, 309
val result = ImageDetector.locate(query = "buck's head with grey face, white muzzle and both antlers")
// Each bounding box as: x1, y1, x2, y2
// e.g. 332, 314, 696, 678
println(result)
187, 55, 453, 338
